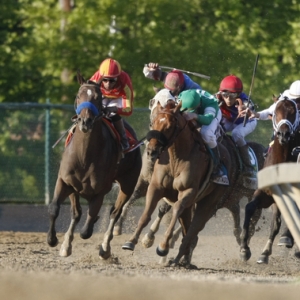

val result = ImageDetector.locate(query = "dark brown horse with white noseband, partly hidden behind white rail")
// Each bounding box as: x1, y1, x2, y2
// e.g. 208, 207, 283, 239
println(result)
240, 99, 300, 264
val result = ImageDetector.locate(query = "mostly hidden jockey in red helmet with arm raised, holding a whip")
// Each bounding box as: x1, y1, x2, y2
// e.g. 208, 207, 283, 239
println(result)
143, 63, 201, 96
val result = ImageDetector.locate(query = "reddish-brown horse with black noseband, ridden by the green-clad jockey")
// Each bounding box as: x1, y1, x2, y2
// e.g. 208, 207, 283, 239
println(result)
123, 103, 264, 265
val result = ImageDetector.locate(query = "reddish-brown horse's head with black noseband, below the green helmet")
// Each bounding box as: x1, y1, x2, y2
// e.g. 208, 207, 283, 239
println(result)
147, 101, 187, 162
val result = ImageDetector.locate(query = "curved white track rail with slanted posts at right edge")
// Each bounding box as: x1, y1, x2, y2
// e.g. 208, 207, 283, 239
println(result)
257, 163, 300, 249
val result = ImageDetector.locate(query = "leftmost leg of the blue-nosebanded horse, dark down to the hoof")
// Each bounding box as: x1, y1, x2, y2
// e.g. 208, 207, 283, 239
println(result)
47, 178, 73, 247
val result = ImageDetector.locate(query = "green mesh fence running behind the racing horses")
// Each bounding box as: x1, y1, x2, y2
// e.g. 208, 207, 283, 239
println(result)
0, 103, 272, 204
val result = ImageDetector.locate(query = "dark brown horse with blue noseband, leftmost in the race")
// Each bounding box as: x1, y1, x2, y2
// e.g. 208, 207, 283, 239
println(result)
47, 73, 141, 259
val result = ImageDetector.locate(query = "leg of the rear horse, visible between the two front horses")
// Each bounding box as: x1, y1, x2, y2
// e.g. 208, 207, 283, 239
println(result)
113, 179, 149, 236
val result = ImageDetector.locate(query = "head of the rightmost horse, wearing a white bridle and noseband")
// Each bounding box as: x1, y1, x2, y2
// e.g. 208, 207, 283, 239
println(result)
273, 98, 299, 145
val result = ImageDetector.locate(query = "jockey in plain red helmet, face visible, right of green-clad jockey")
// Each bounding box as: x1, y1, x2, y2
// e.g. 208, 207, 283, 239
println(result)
216, 75, 257, 178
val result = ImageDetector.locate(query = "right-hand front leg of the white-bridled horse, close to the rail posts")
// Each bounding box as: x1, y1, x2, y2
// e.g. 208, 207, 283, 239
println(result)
257, 203, 281, 264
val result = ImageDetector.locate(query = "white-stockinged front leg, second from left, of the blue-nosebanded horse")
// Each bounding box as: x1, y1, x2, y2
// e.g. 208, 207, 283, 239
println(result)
59, 193, 82, 257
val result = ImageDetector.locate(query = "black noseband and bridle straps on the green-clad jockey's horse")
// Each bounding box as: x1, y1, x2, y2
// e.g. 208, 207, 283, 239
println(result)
146, 112, 188, 151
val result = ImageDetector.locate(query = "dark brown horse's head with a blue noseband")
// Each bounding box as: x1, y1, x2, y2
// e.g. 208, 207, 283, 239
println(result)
75, 72, 103, 133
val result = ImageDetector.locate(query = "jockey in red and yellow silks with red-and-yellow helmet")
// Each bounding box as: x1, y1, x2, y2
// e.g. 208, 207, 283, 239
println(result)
90, 58, 133, 150
